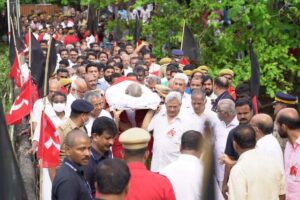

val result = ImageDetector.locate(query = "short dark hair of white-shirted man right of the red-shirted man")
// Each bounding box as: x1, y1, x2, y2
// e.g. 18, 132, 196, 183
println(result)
181, 130, 202, 151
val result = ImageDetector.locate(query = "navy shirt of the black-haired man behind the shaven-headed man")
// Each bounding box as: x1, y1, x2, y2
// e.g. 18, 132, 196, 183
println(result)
84, 147, 112, 197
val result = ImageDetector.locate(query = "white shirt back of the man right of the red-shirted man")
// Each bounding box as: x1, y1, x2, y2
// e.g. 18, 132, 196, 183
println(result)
160, 154, 203, 200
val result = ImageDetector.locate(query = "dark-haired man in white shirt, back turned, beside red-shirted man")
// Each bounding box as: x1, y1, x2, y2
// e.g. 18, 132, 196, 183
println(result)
160, 131, 203, 200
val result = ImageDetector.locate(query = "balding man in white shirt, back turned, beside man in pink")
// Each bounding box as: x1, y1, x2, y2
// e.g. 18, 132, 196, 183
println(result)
250, 114, 283, 168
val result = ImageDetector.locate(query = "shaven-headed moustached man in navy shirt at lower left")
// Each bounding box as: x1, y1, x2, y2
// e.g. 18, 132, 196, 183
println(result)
52, 129, 93, 200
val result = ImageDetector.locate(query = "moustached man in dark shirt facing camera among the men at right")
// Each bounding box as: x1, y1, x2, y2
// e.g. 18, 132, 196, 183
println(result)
221, 99, 253, 199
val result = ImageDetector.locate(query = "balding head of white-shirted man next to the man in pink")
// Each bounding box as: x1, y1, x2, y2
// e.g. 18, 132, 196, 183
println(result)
250, 113, 274, 135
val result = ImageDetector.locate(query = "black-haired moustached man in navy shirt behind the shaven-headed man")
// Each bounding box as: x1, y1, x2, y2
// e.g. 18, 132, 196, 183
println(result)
85, 117, 118, 197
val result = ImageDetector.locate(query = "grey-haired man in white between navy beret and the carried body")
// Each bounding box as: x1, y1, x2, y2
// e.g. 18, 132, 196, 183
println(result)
84, 91, 112, 136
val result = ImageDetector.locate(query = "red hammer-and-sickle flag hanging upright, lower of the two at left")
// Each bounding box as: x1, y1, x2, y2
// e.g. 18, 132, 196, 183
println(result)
38, 111, 60, 168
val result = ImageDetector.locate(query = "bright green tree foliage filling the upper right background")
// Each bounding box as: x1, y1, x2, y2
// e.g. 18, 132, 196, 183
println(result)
0, 0, 300, 98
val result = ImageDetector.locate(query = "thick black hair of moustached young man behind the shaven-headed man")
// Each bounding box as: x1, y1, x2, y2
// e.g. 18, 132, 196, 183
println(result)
92, 117, 118, 137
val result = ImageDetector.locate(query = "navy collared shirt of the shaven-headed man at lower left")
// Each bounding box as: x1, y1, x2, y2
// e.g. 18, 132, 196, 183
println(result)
52, 158, 93, 200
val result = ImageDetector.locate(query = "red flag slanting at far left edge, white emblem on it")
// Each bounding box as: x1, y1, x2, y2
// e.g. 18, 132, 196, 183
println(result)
6, 79, 32, 125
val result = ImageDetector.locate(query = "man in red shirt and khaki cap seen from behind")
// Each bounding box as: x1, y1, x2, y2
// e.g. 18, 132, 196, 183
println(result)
119, 128, 176, 200
